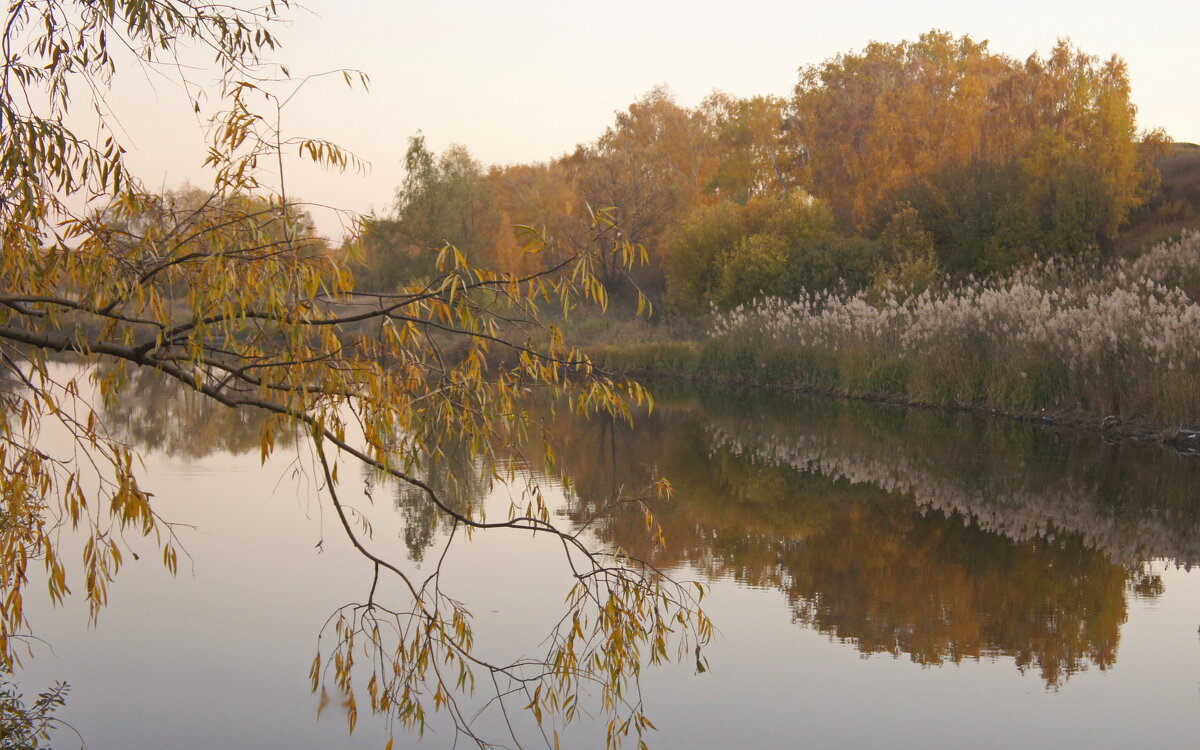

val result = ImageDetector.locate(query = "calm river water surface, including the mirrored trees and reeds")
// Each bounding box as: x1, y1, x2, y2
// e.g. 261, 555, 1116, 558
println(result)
19, 362, 1200, 750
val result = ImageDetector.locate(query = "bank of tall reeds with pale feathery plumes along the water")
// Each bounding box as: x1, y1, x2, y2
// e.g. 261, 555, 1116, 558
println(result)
593, 233, 1200, 432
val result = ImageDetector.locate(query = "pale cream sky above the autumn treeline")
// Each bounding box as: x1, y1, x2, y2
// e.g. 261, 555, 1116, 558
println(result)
109, 0, 1200, 234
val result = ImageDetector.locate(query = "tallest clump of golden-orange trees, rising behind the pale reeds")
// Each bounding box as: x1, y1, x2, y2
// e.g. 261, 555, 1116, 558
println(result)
792, 31, 1164, 271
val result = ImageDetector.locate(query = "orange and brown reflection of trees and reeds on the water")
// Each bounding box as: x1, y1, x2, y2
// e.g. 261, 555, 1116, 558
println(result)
106, 373, 1200, 688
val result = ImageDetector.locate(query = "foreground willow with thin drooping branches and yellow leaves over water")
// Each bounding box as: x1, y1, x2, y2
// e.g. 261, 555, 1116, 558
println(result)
0, 0, 708, 746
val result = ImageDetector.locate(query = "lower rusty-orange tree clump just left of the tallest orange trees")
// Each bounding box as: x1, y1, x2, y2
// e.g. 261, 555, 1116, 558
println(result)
488, 88, 796, 307
